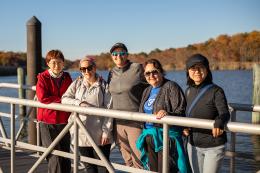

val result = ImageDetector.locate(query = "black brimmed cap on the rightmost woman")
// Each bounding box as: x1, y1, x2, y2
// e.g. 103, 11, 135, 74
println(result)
186, 54, 209, 70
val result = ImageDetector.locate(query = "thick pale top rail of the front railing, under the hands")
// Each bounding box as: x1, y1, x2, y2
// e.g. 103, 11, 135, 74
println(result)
0, 96, 260, 135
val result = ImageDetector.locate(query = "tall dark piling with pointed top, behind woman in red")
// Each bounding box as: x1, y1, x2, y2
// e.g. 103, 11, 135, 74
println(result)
26, 16, 42, 144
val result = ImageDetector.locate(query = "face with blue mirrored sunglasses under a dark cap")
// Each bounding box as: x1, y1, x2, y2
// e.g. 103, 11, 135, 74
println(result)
111, 48, 128, 68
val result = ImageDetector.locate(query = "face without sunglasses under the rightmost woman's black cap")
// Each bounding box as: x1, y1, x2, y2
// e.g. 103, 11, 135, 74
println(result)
188, 64, 208, 85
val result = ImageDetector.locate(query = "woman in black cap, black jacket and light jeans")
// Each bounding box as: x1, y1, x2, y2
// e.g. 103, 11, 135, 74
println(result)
184, 54, 230, 173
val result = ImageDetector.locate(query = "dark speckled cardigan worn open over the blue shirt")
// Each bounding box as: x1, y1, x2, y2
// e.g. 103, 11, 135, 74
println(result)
139, 79, 186, 127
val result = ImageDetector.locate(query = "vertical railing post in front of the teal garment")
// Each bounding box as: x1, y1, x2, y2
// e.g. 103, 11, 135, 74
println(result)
163, 123, 169, 173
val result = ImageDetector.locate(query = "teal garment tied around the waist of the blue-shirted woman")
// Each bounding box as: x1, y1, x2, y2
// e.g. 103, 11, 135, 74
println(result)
136, 127, 188, 173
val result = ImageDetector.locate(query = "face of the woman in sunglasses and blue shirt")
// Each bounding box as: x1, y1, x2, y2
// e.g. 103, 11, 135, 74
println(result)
144, 64, 163, 87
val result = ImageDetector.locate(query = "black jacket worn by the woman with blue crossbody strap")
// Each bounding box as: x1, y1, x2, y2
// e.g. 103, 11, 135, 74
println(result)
185, 83, 230, 148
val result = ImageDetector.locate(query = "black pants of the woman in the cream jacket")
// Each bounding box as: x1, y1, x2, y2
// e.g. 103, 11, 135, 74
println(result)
79, 144, 111, 173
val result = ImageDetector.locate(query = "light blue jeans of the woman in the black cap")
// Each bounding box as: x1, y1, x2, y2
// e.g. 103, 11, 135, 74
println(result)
187, 143, 225, 173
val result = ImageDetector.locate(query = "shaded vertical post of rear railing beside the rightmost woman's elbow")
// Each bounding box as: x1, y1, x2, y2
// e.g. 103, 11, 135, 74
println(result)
230, 108, 236, 173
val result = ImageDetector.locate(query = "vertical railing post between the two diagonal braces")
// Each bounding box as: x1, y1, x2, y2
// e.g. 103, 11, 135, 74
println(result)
73, 113, 79, 173
